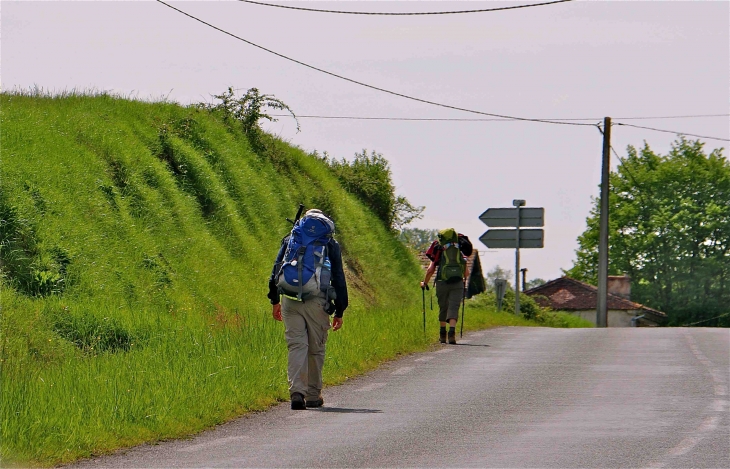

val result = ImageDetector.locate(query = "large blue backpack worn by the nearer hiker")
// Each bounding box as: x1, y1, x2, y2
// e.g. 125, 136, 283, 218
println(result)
276, 213, 335, 301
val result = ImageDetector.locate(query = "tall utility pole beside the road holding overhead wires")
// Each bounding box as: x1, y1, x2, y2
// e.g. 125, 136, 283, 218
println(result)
596, 117, 611, 327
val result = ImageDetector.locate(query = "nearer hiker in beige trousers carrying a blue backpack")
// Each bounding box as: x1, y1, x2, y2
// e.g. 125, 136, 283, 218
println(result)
268, 208, 348, 410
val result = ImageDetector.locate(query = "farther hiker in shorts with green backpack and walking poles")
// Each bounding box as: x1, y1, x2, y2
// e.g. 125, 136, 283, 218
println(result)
421, 228, 473, 344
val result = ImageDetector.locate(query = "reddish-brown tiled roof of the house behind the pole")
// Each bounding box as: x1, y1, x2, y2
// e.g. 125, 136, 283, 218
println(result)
525, 277, 667, 318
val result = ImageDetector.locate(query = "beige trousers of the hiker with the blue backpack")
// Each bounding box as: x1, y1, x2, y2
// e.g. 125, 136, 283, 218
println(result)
281, 297, 331, 400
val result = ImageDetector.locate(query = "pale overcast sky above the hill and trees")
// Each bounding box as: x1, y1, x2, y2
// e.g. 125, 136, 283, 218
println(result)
0, 0, 730, 280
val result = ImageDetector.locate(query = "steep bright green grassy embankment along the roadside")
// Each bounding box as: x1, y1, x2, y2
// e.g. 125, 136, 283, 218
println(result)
0, 94, 588, 466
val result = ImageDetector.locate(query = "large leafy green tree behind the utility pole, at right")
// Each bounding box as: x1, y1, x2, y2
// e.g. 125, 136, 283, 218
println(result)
566, 137, 730, 326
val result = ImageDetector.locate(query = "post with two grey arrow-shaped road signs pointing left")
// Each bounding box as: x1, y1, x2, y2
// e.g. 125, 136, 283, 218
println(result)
479, 199, 545, 314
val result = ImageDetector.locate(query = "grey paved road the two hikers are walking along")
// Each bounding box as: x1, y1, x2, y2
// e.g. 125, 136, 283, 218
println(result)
69, 328, 730, 468
